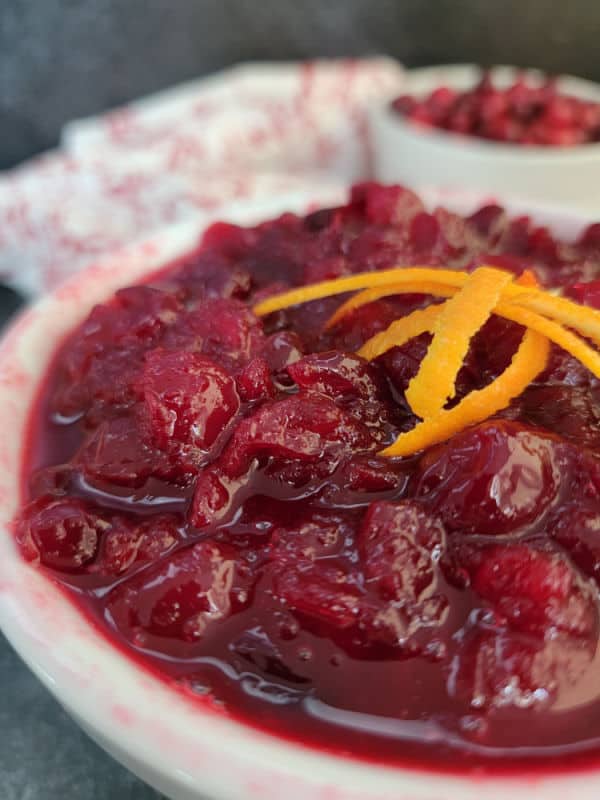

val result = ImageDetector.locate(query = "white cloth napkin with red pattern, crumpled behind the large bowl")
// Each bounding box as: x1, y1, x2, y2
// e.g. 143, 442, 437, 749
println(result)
0, 58, 403, 296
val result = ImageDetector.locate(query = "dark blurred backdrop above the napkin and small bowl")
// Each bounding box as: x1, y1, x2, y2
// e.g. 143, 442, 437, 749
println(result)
0, 0, 600, 169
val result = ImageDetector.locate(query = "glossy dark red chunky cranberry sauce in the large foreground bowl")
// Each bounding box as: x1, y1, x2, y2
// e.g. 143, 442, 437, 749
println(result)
16, 184, 600, 769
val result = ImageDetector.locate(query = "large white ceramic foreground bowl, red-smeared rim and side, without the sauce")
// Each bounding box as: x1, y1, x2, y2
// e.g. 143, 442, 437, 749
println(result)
0, 189, 600, 800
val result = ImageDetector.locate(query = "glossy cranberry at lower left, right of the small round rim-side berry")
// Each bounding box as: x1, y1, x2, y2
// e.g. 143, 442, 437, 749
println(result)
107, 540, 243, 650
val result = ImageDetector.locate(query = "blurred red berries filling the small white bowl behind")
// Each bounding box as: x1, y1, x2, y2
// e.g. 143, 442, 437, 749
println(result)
392, 73, 600, 147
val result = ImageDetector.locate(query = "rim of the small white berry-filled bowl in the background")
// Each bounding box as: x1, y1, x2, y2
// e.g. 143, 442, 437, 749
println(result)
384, 63, 600, 159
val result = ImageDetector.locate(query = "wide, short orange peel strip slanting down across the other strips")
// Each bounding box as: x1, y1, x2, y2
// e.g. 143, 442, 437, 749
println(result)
406, 267, 513, 419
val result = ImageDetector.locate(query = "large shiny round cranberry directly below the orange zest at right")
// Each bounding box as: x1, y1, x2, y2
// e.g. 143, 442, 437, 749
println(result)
415, 420, 567, 534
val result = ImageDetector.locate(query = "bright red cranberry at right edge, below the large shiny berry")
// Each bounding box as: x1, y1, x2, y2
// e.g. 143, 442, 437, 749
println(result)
472, 544, 597, 639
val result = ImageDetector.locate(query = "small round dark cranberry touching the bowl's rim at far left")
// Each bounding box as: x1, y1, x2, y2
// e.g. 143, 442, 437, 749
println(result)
17, 497, 102, 572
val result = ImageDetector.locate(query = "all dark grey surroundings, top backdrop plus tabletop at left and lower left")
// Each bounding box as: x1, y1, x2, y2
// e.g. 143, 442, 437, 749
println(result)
0, 0, 600, 800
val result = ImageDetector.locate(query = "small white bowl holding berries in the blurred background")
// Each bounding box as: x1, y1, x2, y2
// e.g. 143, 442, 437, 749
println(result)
370, 64, 600, 215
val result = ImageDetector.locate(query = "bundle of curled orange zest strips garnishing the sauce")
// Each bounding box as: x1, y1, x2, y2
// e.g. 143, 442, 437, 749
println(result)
254, 266, 600, 456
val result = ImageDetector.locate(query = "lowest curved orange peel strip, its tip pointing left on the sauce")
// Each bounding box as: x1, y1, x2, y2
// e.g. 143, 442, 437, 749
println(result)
379, 330, 550, 457
